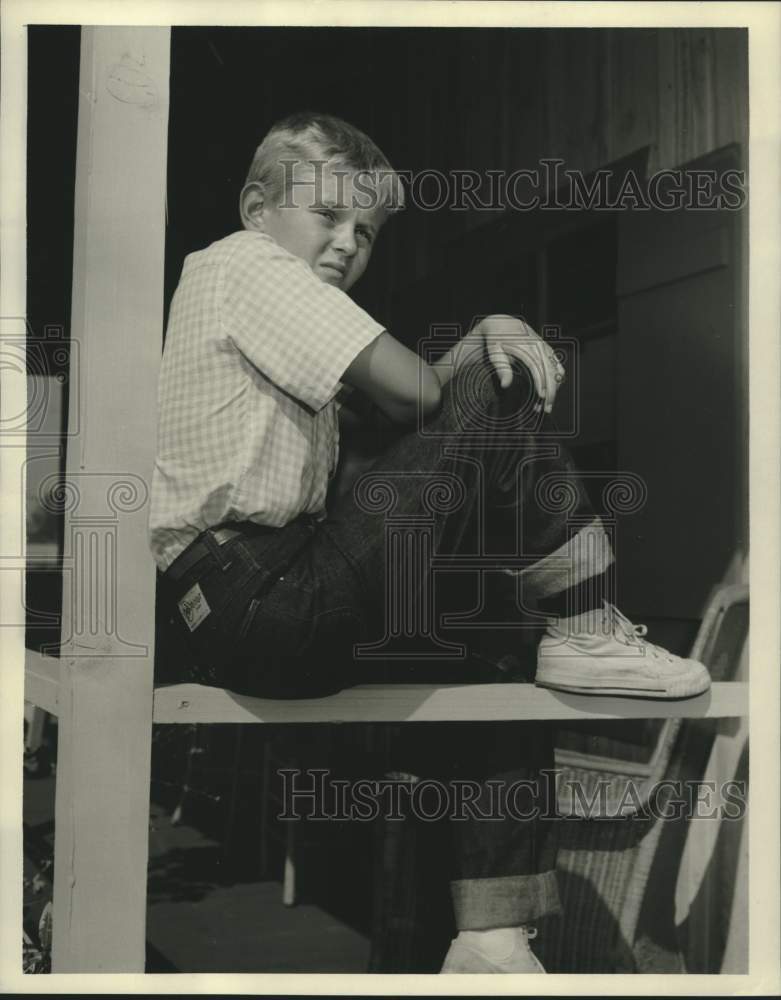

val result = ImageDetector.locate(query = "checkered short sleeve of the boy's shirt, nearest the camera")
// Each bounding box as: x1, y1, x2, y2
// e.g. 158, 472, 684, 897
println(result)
220, 233, 384, 410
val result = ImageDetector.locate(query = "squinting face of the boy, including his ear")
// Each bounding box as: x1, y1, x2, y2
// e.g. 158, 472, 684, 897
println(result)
242, 162, 386, 292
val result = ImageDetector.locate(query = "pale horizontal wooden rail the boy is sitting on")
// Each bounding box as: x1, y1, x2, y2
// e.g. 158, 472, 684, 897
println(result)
154, 683, 748, 723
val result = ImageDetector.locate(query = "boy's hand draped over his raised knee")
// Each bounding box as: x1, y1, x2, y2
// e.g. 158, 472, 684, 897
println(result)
466, 315, 565, 413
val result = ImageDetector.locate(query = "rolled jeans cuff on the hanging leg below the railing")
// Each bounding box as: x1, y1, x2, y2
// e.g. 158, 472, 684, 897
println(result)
450, 871, 561, 931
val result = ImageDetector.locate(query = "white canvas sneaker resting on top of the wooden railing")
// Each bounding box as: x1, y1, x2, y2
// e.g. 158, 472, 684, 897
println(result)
535, 601, 710, 698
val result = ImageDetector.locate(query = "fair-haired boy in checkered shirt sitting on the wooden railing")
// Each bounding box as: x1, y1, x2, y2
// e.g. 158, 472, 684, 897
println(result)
150, 114, 709, 972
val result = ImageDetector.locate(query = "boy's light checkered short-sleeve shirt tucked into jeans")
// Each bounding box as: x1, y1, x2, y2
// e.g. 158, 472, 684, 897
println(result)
149, 231, 384, 569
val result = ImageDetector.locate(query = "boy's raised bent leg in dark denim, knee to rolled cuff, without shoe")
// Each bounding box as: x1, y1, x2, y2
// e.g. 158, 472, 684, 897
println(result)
324, 366, 613, 627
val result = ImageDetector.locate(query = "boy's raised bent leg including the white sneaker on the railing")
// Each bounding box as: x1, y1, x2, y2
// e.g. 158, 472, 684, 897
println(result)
324, 366, 710, 698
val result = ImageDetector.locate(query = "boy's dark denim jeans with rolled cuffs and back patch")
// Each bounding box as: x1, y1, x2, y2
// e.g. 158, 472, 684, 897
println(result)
158, 367, 612, 929
